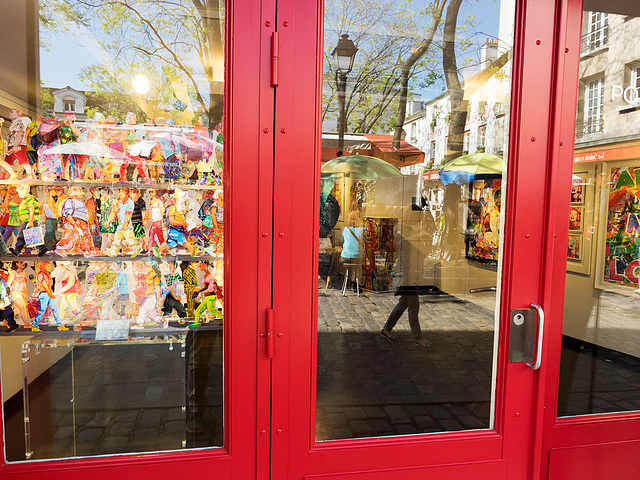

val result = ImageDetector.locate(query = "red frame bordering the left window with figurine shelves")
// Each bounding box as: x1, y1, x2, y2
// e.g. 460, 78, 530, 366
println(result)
0, 0, 275, 480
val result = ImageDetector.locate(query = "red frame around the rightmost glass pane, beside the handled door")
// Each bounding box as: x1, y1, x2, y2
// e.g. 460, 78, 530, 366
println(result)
535, 0, 640, 480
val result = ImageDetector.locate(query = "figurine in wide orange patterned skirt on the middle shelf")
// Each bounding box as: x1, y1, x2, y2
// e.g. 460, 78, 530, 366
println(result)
51, 186, 98, 257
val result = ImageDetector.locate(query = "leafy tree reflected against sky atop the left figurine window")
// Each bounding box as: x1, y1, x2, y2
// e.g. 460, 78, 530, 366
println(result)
40, 0, 224, 125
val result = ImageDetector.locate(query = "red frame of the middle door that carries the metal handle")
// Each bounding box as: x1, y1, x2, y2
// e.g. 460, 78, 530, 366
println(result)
271, 0, 576, 479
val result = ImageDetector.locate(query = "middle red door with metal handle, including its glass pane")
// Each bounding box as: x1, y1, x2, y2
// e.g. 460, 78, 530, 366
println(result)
270, 0, 571, 479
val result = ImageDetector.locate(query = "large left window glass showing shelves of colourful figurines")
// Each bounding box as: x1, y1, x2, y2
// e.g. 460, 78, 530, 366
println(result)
0, 0, 226, 462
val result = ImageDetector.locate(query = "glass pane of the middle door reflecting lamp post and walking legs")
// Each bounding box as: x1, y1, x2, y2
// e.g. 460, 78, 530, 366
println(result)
316, 0, 515, 441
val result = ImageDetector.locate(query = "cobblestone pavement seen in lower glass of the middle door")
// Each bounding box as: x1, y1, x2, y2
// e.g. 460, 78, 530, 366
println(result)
316, 289, 494, 440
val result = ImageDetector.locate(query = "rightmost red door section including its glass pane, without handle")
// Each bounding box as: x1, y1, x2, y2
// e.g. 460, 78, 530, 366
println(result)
538, 1, 640, 479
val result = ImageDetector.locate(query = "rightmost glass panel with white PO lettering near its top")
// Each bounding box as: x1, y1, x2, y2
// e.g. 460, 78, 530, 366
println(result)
557, 1, 640, 416
